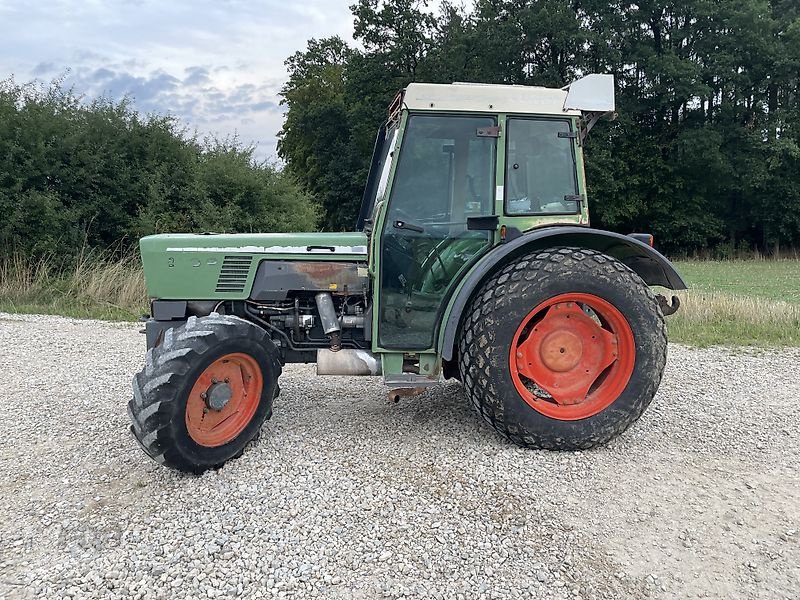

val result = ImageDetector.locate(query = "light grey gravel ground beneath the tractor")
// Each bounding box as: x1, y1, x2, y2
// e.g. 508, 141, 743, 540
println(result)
0, 314, 800, 599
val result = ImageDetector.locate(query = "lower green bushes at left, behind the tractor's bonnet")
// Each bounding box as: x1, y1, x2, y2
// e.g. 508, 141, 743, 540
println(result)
0, 79, 318, 261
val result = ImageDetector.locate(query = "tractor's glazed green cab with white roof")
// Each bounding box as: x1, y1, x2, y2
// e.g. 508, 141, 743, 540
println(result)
358, 75, 614, 351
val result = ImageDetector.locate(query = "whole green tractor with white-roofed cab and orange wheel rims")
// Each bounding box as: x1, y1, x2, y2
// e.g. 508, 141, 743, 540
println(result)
128, 75, 686, 473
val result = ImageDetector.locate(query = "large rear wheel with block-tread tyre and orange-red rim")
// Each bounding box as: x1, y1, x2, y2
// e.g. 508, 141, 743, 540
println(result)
459, 248, 667, 450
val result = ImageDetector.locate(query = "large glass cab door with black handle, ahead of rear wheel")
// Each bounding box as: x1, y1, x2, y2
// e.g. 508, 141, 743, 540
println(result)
378, 114, 497, 350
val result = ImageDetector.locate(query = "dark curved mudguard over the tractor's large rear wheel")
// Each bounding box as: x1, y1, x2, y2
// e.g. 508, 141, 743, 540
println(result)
439, 225, 686, 360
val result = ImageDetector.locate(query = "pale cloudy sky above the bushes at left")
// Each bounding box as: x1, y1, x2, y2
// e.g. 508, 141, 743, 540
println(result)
0, 0, 353, 158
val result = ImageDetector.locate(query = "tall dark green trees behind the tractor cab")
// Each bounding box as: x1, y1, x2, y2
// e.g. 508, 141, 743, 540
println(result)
278, 0, 800, 253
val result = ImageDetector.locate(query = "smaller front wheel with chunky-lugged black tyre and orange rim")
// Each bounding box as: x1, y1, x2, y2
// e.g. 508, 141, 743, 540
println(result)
128, 313, 281, 473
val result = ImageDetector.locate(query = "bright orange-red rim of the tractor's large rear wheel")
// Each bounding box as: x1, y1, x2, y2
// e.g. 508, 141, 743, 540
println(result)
509, 293, 636, 421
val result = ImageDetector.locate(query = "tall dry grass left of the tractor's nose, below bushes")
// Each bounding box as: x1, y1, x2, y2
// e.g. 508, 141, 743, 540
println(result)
0, 250, 147, 320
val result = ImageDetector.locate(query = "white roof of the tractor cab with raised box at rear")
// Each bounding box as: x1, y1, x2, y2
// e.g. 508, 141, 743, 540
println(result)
403, 75, 614, 116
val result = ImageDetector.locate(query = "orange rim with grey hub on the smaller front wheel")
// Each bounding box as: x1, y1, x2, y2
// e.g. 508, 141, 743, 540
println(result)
186, 352, 264, 448
